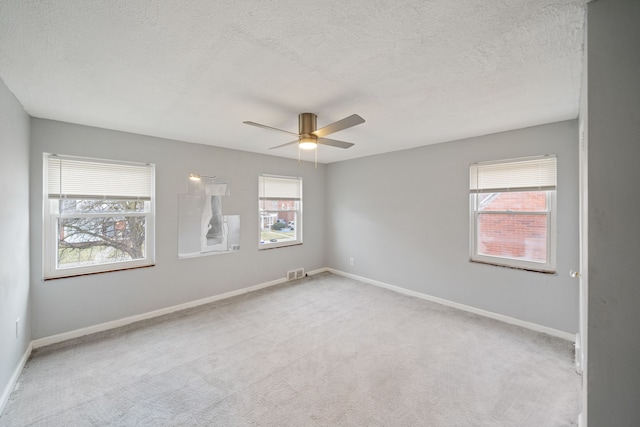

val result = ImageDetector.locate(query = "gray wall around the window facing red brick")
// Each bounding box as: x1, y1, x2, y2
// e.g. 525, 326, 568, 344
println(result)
327, 120, 579, 333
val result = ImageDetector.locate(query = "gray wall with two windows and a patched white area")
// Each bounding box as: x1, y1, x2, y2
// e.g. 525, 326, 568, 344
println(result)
31, 119, 326, 339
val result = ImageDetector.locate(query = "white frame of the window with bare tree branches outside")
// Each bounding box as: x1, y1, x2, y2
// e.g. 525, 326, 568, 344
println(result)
42, 153, 155, 280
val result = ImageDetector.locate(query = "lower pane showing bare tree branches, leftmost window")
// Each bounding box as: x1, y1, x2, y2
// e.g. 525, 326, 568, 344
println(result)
58, 216, 146, 268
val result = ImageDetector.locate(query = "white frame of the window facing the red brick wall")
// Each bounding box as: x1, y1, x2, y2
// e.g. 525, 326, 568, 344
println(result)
469, 155, 557, 274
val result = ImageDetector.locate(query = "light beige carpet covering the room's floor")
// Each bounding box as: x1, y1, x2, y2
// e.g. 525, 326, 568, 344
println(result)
0, 273, 581, 427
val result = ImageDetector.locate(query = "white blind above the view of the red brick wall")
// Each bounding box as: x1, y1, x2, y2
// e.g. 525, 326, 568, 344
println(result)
469, 156, 557, 193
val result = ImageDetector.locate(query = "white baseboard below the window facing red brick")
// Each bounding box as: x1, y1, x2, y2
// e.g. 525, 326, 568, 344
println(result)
327, 268, 576, 343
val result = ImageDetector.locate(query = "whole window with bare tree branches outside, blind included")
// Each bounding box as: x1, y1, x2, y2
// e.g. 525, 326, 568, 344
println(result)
44, 154, 154, 278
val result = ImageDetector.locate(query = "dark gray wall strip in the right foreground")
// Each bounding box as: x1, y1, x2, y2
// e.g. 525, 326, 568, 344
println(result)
587, 0, 640, 427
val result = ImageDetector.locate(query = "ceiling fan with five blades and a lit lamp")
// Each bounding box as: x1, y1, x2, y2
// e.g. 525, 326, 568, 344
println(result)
242, 113, 364, 150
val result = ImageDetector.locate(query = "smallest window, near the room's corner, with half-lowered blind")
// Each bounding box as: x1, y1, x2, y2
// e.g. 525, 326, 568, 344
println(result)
259, 175, 302, 249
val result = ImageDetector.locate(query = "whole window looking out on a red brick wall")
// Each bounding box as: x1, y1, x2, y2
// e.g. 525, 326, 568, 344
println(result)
469, 156, 556, 272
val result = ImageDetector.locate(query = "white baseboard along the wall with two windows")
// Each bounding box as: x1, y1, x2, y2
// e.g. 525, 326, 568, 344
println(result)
31, 272, 296, 349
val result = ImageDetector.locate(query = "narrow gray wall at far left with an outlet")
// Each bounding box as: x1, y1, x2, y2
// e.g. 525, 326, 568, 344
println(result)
0, 79, 31, 410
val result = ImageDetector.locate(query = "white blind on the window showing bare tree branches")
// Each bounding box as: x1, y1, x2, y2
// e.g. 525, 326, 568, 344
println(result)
46, 155, 153, 200
